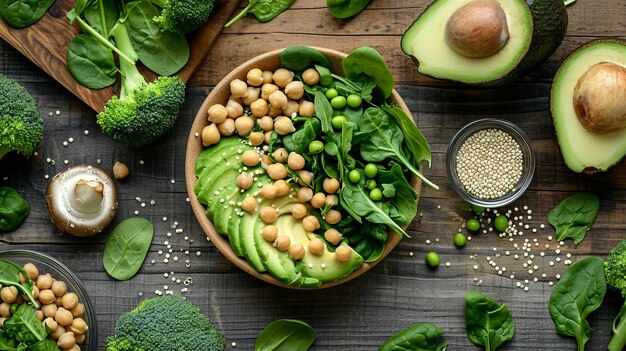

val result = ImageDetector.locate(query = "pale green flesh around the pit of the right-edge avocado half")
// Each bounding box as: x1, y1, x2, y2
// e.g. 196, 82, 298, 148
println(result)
550, 40, 626, 173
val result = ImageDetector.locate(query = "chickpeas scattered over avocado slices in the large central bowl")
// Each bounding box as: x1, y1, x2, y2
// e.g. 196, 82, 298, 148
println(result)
201, 68, 352, 261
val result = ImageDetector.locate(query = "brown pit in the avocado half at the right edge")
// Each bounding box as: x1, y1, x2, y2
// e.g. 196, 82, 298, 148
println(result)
574, 62, 626, 134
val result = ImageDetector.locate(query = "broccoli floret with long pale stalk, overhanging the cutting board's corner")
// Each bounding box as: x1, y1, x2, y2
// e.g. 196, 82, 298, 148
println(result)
97, 22, 185, 146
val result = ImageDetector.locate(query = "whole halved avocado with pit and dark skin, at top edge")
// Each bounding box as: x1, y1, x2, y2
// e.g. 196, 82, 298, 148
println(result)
401, 0, 567, 86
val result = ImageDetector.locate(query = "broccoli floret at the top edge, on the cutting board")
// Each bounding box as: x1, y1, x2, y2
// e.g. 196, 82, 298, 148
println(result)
150, 0, 215, 33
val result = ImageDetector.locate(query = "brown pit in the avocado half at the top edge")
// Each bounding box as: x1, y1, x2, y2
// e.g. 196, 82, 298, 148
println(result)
445, 0, 509, 58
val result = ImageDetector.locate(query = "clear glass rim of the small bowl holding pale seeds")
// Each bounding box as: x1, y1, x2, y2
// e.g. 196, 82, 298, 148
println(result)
446, 118, 536, 208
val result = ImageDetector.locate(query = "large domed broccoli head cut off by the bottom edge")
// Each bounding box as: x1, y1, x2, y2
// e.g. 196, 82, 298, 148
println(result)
106, 295, 225, 351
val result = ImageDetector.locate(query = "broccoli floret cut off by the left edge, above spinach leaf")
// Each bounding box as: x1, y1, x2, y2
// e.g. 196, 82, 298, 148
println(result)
0, 74, 43, 159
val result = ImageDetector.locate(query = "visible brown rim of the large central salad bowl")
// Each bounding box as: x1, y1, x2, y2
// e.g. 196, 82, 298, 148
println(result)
185, 46, 422, 290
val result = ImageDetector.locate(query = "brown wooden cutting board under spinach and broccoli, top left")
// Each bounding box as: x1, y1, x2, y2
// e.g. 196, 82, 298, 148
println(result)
0, 0, 239, 112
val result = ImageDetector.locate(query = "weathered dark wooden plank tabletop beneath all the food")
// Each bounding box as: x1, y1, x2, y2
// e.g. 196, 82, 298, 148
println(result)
0, 0, 626, 350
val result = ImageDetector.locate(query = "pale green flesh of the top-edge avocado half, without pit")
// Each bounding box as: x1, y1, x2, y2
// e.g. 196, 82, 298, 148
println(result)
401, 0, 533, 84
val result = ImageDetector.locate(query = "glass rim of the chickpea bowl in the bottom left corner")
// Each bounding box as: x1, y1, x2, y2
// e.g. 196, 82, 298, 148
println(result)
0, 249, 98, 350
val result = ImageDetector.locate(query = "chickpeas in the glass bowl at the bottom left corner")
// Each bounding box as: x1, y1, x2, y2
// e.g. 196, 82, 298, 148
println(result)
0, 263, 89, 351
